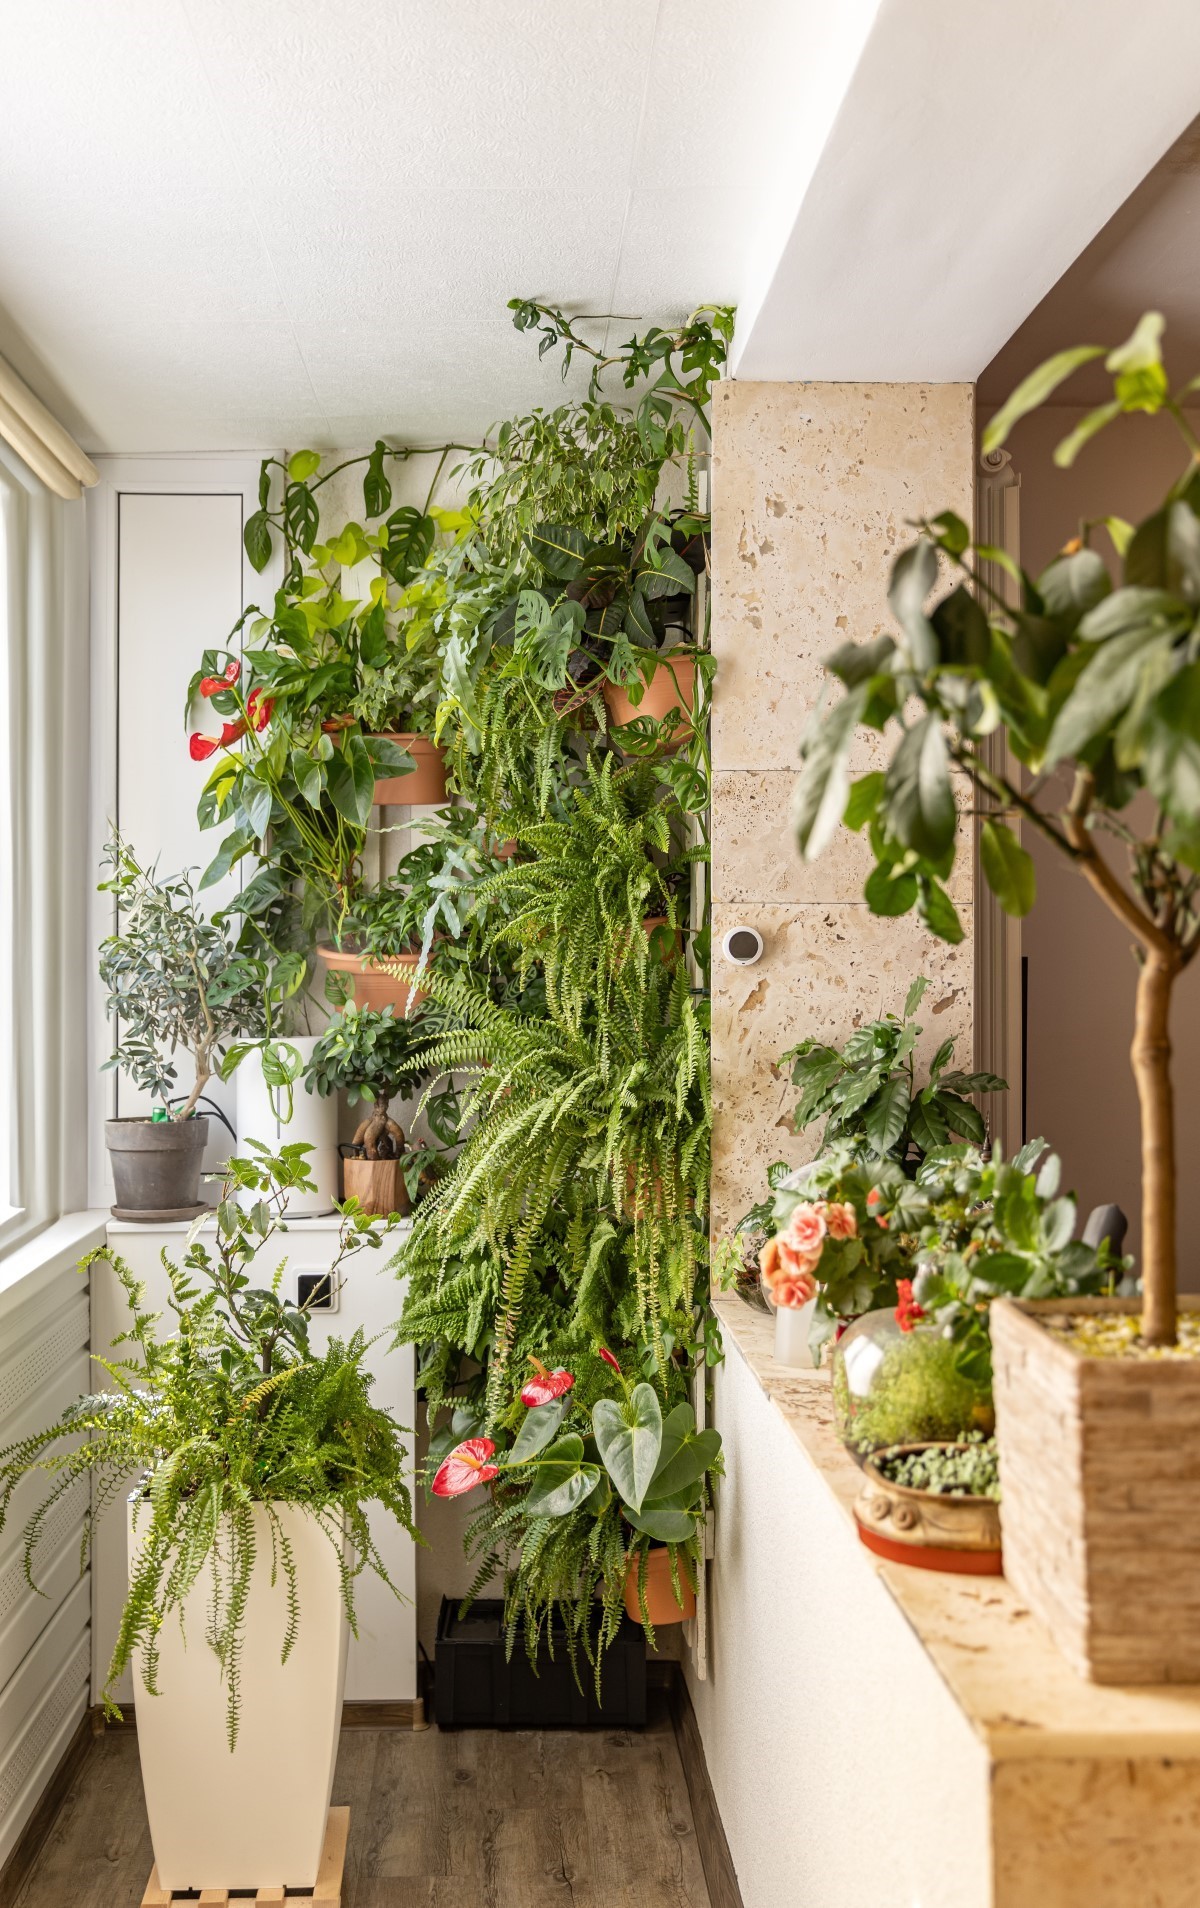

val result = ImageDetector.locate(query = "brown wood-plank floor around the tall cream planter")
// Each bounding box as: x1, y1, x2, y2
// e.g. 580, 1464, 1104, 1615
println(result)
19, 1692, 710, 1908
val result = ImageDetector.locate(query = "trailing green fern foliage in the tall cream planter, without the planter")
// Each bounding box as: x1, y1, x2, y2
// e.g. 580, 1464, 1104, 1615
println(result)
0, 1141, 412, 1750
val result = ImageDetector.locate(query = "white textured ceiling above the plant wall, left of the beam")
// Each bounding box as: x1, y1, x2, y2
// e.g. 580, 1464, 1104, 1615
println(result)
0, 0, 828, 450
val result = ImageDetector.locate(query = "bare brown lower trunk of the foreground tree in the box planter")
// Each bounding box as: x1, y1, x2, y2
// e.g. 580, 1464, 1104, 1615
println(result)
1129, 948, 1179, 1345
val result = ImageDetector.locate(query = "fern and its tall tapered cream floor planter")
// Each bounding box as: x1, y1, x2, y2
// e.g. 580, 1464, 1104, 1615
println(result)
0, 1147, 412, 1893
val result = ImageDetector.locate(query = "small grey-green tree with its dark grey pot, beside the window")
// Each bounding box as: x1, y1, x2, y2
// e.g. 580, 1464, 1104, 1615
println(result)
99, 834, 267, 1223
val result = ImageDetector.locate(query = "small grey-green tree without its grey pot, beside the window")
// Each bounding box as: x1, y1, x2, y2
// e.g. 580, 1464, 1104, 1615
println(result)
99, 832, 267, 1120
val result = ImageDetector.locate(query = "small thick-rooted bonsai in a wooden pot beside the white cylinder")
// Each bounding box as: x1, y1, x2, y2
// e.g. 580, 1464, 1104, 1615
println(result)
305, 1006, 429, 1213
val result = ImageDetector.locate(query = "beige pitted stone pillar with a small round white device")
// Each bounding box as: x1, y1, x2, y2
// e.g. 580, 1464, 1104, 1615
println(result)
714, 382, 975, 1225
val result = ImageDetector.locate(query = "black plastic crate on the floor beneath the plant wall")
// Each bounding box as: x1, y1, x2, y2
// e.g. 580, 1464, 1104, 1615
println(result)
433, 1597, 647, 1729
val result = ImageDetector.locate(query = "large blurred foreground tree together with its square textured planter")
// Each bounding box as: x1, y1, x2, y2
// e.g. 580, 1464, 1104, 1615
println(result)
797, 313, 1200, 1683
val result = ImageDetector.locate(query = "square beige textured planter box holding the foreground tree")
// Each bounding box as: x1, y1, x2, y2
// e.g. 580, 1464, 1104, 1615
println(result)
992, 1299, 1200, 1683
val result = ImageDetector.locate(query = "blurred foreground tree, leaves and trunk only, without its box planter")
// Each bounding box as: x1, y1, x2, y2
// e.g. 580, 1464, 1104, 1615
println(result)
797, 313, 1200, 1345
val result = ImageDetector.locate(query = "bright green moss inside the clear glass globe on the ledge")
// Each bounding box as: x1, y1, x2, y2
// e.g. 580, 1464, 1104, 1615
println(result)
834, 1332, 994, 1456
